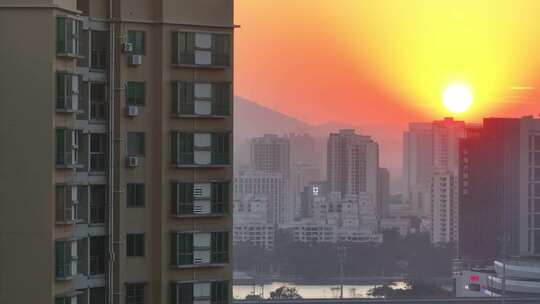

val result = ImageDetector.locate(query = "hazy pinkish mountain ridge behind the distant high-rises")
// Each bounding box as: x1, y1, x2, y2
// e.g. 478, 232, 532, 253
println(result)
234, 96, 403, 189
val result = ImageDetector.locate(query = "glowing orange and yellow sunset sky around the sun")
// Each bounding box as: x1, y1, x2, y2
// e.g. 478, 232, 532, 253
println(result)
235, 0, 540, 125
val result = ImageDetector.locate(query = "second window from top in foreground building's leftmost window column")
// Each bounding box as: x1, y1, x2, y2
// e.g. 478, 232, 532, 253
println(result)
56, 73, 79, 112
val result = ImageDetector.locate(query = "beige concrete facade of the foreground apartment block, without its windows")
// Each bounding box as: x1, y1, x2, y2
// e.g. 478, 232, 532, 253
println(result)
0, 0, 234, 304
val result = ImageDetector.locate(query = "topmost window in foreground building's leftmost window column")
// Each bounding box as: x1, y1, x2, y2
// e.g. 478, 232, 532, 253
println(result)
56, 16, 82, 56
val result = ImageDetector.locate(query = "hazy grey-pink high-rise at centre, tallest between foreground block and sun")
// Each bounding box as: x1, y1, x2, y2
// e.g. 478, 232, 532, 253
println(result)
327, 129, 379, 207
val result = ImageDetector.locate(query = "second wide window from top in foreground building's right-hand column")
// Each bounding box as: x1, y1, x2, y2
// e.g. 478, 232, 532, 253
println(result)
171, 81, 231, 116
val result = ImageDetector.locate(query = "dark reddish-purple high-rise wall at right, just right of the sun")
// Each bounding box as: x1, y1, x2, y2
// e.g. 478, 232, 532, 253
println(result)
459, 118, 520, 260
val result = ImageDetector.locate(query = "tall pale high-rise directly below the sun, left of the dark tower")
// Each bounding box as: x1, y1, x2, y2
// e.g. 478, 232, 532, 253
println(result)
403, 117, 465, 243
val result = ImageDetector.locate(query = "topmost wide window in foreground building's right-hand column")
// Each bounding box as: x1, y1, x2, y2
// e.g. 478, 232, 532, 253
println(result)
172, 32, 231, 66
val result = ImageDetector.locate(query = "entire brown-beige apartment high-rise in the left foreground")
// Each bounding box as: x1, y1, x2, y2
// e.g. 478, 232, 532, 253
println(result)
0, 0, 234, 304
